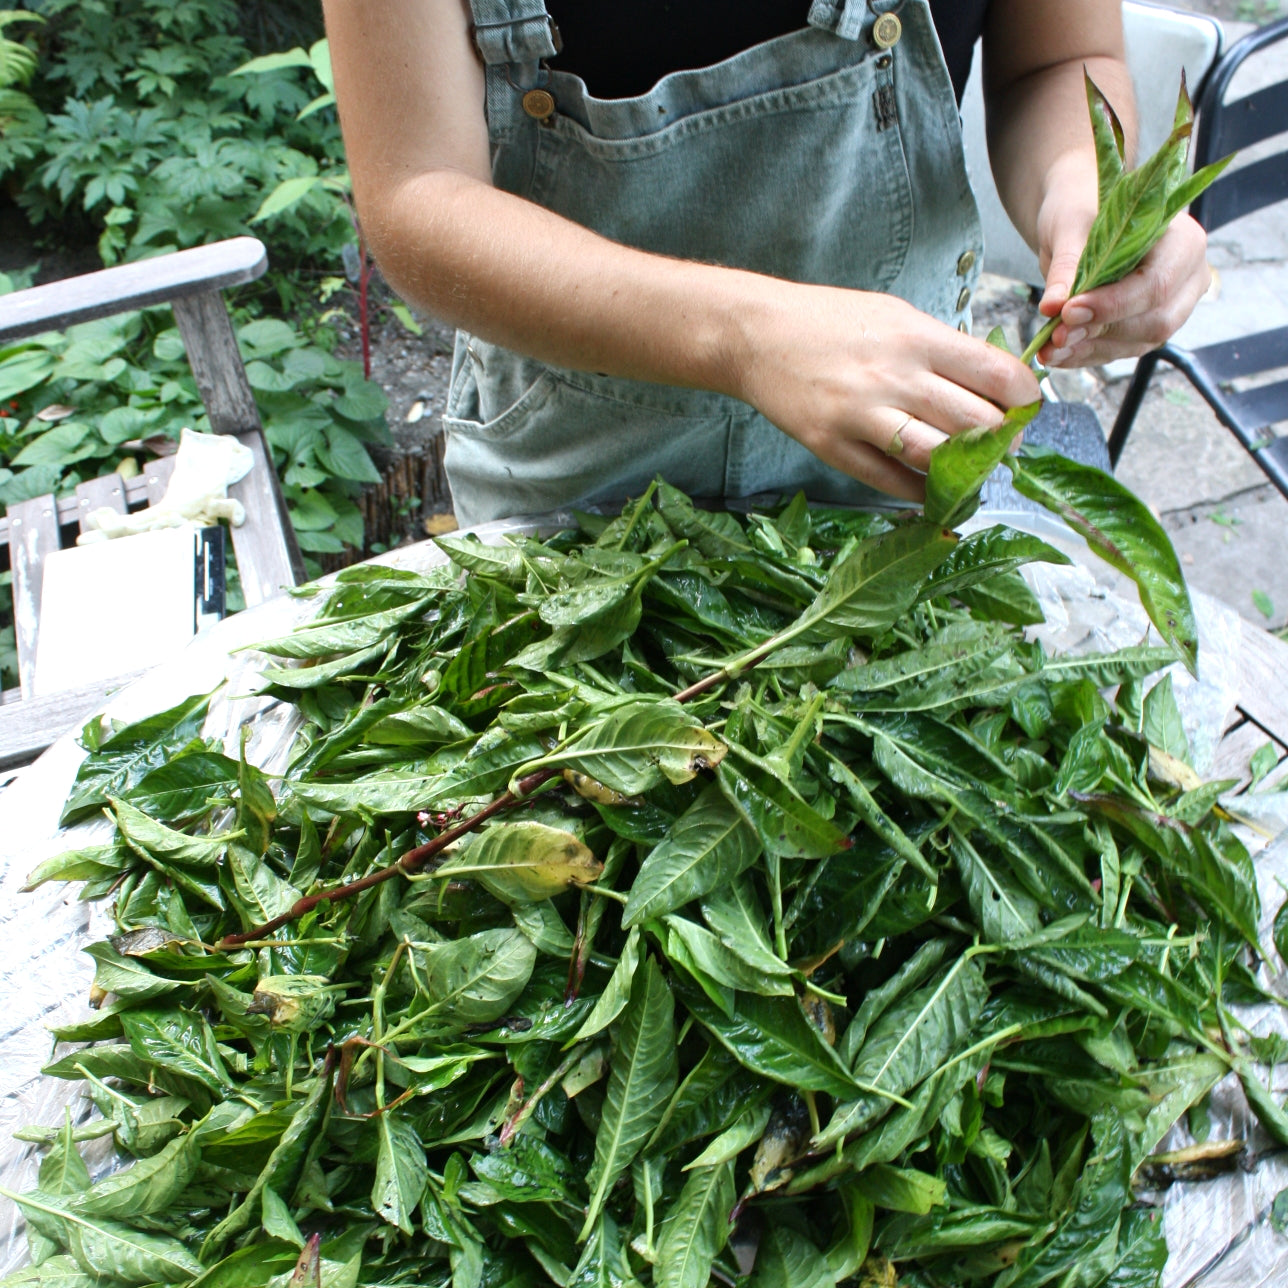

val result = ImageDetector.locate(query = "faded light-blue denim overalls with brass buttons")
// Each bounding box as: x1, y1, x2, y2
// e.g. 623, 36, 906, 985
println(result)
443, 0, 983, 524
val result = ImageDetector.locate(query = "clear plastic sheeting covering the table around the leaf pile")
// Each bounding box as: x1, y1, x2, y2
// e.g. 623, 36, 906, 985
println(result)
0, 511, 1288, 1288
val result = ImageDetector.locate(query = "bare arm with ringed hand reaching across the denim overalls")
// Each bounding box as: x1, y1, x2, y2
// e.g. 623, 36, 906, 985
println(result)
323, 0, 1037, 498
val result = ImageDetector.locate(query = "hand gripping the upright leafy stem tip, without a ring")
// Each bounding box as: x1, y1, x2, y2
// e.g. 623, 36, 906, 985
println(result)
1038, 198, 1212, 367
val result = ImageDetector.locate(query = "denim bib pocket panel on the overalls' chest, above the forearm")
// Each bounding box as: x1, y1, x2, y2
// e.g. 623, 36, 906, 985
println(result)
529, 50, 914, 291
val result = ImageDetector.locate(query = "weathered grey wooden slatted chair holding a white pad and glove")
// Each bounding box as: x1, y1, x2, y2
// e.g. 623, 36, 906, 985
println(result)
0, 237, 304, 768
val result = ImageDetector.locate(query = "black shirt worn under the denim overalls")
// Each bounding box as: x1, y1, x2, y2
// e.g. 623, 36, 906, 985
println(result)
546, 0, 988, 103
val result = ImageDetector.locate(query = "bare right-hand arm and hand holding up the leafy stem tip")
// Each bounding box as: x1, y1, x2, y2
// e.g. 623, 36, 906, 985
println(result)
984, 0, 1208, 366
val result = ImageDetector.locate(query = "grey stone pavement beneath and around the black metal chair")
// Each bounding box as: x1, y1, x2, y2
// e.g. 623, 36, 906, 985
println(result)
975, 13, 1288, 627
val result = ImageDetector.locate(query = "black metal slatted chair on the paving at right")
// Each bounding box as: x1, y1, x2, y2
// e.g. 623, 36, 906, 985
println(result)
1109, 18, 1288, 497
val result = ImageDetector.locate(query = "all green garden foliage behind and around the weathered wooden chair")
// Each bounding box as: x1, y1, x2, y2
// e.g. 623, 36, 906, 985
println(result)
0, 0, 419, 687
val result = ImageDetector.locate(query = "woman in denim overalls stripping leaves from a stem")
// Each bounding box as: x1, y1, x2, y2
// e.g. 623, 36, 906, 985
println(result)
325, 0, 1208, 523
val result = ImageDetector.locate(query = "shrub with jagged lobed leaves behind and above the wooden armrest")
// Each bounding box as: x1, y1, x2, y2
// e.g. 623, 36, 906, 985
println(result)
0, 0, 353, 273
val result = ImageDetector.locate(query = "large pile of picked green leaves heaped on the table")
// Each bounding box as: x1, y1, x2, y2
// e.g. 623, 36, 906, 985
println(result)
5, 435, 1288, 1288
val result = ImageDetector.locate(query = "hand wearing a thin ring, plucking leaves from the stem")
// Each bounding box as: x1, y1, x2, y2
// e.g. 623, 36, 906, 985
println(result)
729, 281, 1039, 501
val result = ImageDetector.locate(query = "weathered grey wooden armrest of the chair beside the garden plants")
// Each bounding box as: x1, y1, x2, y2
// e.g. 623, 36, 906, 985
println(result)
0, 237, 268, 343
